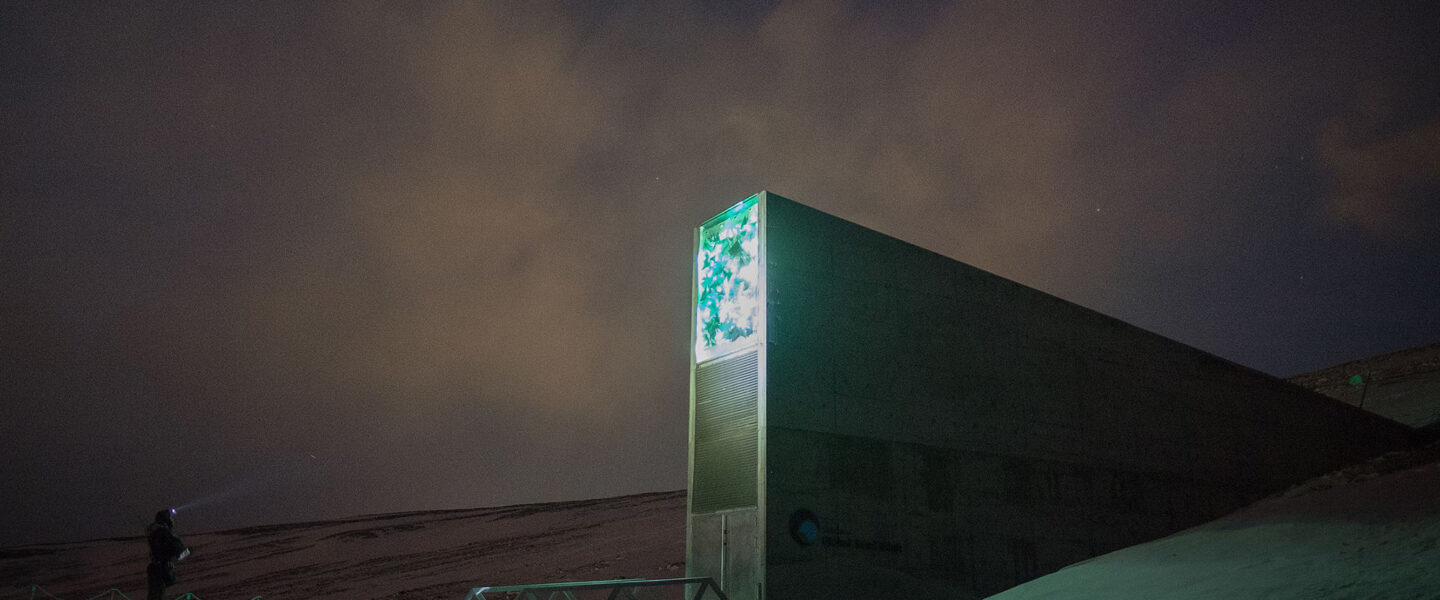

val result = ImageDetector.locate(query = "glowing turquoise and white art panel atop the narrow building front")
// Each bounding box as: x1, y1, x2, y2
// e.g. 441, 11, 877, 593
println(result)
696, 194, 760, 363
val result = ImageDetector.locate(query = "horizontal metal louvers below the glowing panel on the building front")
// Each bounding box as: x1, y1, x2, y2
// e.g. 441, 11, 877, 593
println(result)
690, 350, 760, 514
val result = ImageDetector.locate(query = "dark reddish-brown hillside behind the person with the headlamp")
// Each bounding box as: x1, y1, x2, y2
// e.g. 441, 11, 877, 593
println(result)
0, 492, 685, 600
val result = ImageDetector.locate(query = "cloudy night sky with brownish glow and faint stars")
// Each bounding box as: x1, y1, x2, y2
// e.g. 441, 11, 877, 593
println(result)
0, 1, 1440, 545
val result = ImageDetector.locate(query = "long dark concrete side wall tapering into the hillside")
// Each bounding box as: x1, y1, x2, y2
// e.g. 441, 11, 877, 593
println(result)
762, 194, 1416, 600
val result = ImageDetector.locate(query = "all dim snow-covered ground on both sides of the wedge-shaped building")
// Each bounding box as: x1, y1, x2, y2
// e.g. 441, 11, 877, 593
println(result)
8, 345, 1440, 600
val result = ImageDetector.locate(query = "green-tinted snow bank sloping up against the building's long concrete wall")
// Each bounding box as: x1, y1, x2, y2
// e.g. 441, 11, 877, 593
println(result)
991, 445, 1440, 600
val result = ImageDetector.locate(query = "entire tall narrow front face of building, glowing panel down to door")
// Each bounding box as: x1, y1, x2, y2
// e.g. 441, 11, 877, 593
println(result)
685, 191, 769, 600
